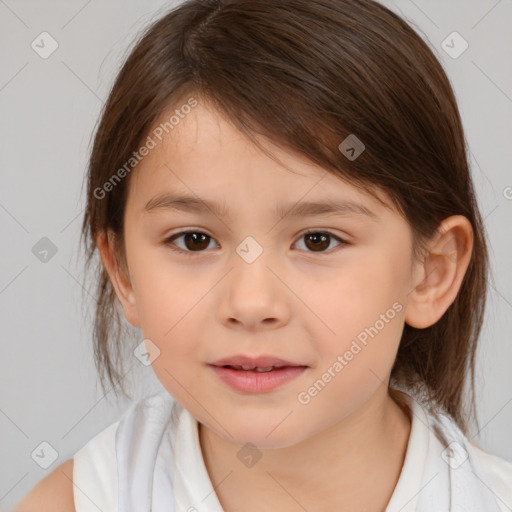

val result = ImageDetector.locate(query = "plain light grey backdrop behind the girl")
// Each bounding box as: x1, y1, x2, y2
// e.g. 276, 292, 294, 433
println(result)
0, 0, 512, 509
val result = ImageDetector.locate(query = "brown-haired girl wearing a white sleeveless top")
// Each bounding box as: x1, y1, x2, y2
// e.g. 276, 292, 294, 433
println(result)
16, 0, 512, 512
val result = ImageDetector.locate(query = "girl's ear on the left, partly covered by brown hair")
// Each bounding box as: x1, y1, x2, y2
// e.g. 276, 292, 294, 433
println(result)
97, 231, 140, 327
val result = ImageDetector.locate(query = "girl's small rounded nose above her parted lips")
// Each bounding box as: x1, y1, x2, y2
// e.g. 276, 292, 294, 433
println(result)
218, 255, 290, 331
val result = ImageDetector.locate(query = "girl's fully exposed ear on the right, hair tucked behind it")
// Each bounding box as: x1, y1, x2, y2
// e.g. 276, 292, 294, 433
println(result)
405, 215, 473, 329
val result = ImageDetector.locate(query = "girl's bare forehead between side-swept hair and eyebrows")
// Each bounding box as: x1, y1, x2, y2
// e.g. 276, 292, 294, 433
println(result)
129, 101, 390, 218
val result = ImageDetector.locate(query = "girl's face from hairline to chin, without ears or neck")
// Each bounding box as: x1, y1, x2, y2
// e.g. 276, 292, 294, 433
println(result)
115, 102, 413, 448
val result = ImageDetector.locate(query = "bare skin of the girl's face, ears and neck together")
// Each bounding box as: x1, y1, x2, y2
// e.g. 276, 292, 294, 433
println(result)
98, 100, 473, 512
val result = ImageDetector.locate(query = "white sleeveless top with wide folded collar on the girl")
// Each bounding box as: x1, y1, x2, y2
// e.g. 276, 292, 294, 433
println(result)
73, 390, 512, 512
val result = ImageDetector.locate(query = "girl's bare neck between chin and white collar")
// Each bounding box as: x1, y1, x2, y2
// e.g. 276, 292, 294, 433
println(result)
199, 386, 411, 512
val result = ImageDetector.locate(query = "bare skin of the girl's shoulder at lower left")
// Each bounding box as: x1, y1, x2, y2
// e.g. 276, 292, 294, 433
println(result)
14, 459, 75, 512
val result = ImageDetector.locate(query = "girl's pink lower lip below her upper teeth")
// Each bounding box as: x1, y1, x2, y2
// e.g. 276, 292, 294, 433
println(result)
210, 365, 307, 393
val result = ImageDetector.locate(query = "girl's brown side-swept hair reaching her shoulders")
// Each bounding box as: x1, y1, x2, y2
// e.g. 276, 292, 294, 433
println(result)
82, 0, 488, 433
